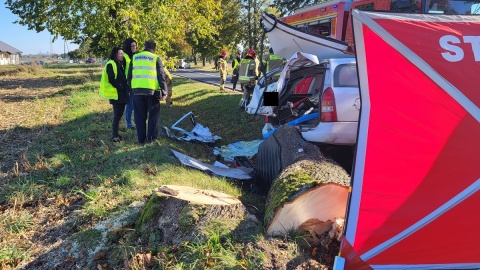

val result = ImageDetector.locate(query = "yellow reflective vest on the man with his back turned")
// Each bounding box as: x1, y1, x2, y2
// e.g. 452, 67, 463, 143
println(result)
132, 51, 160, 91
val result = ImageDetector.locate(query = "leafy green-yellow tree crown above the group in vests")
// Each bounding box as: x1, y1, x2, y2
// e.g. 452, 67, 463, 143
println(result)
5, 0, 220, 57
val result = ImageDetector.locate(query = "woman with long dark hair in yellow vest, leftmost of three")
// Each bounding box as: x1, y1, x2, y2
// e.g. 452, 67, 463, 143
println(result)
100, 47, 130, 142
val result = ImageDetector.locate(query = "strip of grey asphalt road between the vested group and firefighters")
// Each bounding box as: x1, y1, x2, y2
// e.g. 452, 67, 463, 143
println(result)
170, 68, 241, 92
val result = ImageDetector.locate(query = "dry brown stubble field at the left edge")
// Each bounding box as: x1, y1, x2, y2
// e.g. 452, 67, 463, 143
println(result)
0, 65, 100, 180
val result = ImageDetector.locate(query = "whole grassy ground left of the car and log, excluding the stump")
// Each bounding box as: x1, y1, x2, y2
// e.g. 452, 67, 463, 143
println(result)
0, 65, 330, 269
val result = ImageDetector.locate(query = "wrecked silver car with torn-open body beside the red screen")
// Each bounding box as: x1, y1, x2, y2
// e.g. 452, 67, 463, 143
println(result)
245, 52, 360, 146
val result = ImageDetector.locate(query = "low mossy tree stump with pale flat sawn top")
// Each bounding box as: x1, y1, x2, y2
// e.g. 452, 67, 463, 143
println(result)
137, 185, 251, 245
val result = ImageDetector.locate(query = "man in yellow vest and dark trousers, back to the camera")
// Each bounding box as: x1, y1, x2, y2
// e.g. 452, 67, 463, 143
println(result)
128, 40, 167, 145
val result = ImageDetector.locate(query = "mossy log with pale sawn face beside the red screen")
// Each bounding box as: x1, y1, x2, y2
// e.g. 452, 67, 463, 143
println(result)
265, 160, 350, 235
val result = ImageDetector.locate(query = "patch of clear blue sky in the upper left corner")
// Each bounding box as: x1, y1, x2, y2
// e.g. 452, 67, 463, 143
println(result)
0, 3, 78, 55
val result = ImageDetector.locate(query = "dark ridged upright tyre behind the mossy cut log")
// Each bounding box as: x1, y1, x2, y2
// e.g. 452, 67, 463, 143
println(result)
255, 134, 282, 194
